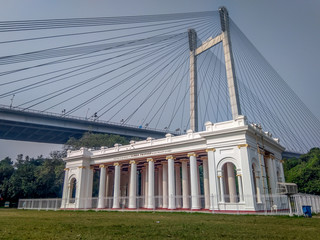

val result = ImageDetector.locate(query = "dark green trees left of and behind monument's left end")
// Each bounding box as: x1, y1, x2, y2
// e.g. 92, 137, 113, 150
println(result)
0, 133, 129, 203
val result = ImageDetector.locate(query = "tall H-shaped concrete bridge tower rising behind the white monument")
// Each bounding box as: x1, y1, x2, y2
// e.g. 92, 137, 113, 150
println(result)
188, 7, 241, 132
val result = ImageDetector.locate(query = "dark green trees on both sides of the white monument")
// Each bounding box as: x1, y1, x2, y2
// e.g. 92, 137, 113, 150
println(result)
0, 133, 320, 206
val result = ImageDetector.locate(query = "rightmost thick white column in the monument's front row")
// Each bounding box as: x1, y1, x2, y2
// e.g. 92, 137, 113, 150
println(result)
188, 153, 200, 209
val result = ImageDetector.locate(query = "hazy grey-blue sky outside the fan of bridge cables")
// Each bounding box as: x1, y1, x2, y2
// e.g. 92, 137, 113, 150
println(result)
0, 0, 320, 159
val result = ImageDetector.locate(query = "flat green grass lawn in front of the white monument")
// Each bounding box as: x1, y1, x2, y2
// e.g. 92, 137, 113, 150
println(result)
0, 209, 320, 240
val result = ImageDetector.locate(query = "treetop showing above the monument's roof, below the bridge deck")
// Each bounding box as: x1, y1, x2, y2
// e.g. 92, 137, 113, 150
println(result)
65, 132, 129, 149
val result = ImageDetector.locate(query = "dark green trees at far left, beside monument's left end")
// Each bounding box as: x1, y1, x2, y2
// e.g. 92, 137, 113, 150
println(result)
0, 152, 65, 202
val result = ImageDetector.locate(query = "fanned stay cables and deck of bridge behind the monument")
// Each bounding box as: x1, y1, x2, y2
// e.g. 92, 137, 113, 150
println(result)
0, 11, 320, 152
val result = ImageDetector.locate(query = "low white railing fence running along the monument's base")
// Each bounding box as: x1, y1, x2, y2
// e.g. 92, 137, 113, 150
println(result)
18, 194, 320, 216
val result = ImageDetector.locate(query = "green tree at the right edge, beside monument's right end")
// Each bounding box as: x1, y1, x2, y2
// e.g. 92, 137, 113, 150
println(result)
283, 148, 320, 195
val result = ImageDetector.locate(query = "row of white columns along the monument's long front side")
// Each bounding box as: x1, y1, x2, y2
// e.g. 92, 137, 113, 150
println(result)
98, 153, 210, 209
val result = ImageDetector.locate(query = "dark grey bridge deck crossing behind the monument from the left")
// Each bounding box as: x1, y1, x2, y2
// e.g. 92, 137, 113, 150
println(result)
0, 106, 170, 144
